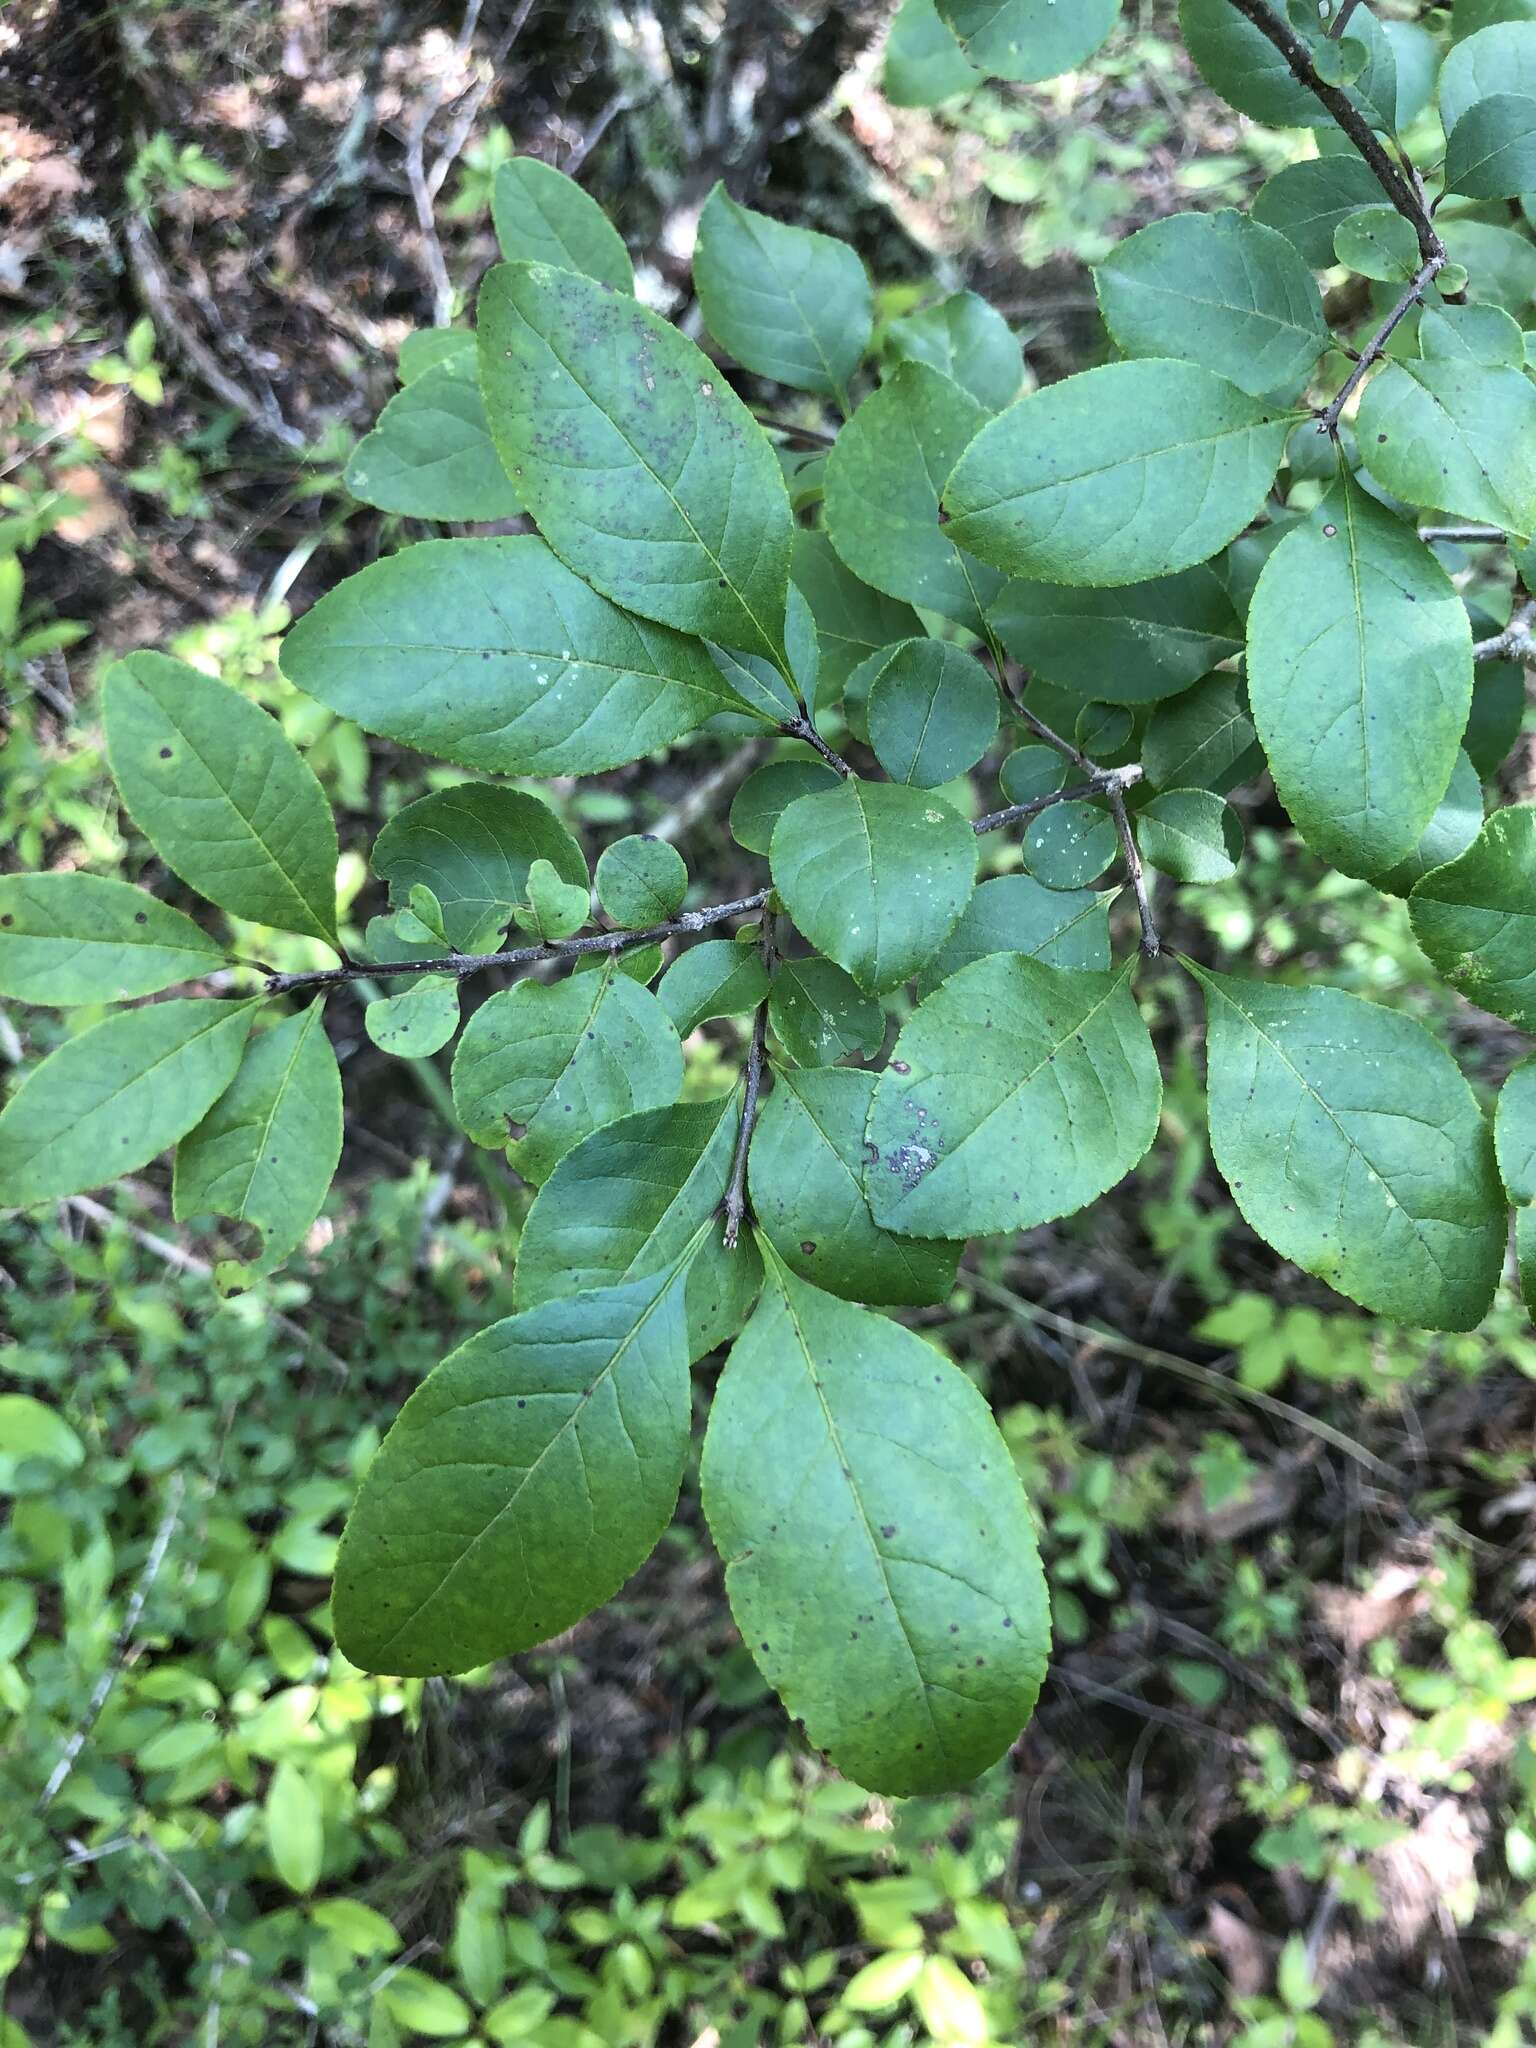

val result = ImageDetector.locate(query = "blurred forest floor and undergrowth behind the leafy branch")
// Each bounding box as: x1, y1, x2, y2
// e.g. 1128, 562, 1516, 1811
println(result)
0, 0, 1536, 2048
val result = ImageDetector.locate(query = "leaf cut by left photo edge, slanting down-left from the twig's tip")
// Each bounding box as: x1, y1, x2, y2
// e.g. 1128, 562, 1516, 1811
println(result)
0, 995, 256, 1208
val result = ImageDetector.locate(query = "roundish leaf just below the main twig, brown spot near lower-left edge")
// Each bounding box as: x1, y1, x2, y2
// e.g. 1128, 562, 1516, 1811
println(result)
453, 961, 682, 1184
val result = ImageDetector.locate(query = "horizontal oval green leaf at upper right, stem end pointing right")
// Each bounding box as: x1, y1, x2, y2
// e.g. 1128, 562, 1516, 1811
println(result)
946, 360, 1294, 586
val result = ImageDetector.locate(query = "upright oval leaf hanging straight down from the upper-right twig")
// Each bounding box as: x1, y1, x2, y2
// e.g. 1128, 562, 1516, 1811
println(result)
1247, 477, 1473, 874
